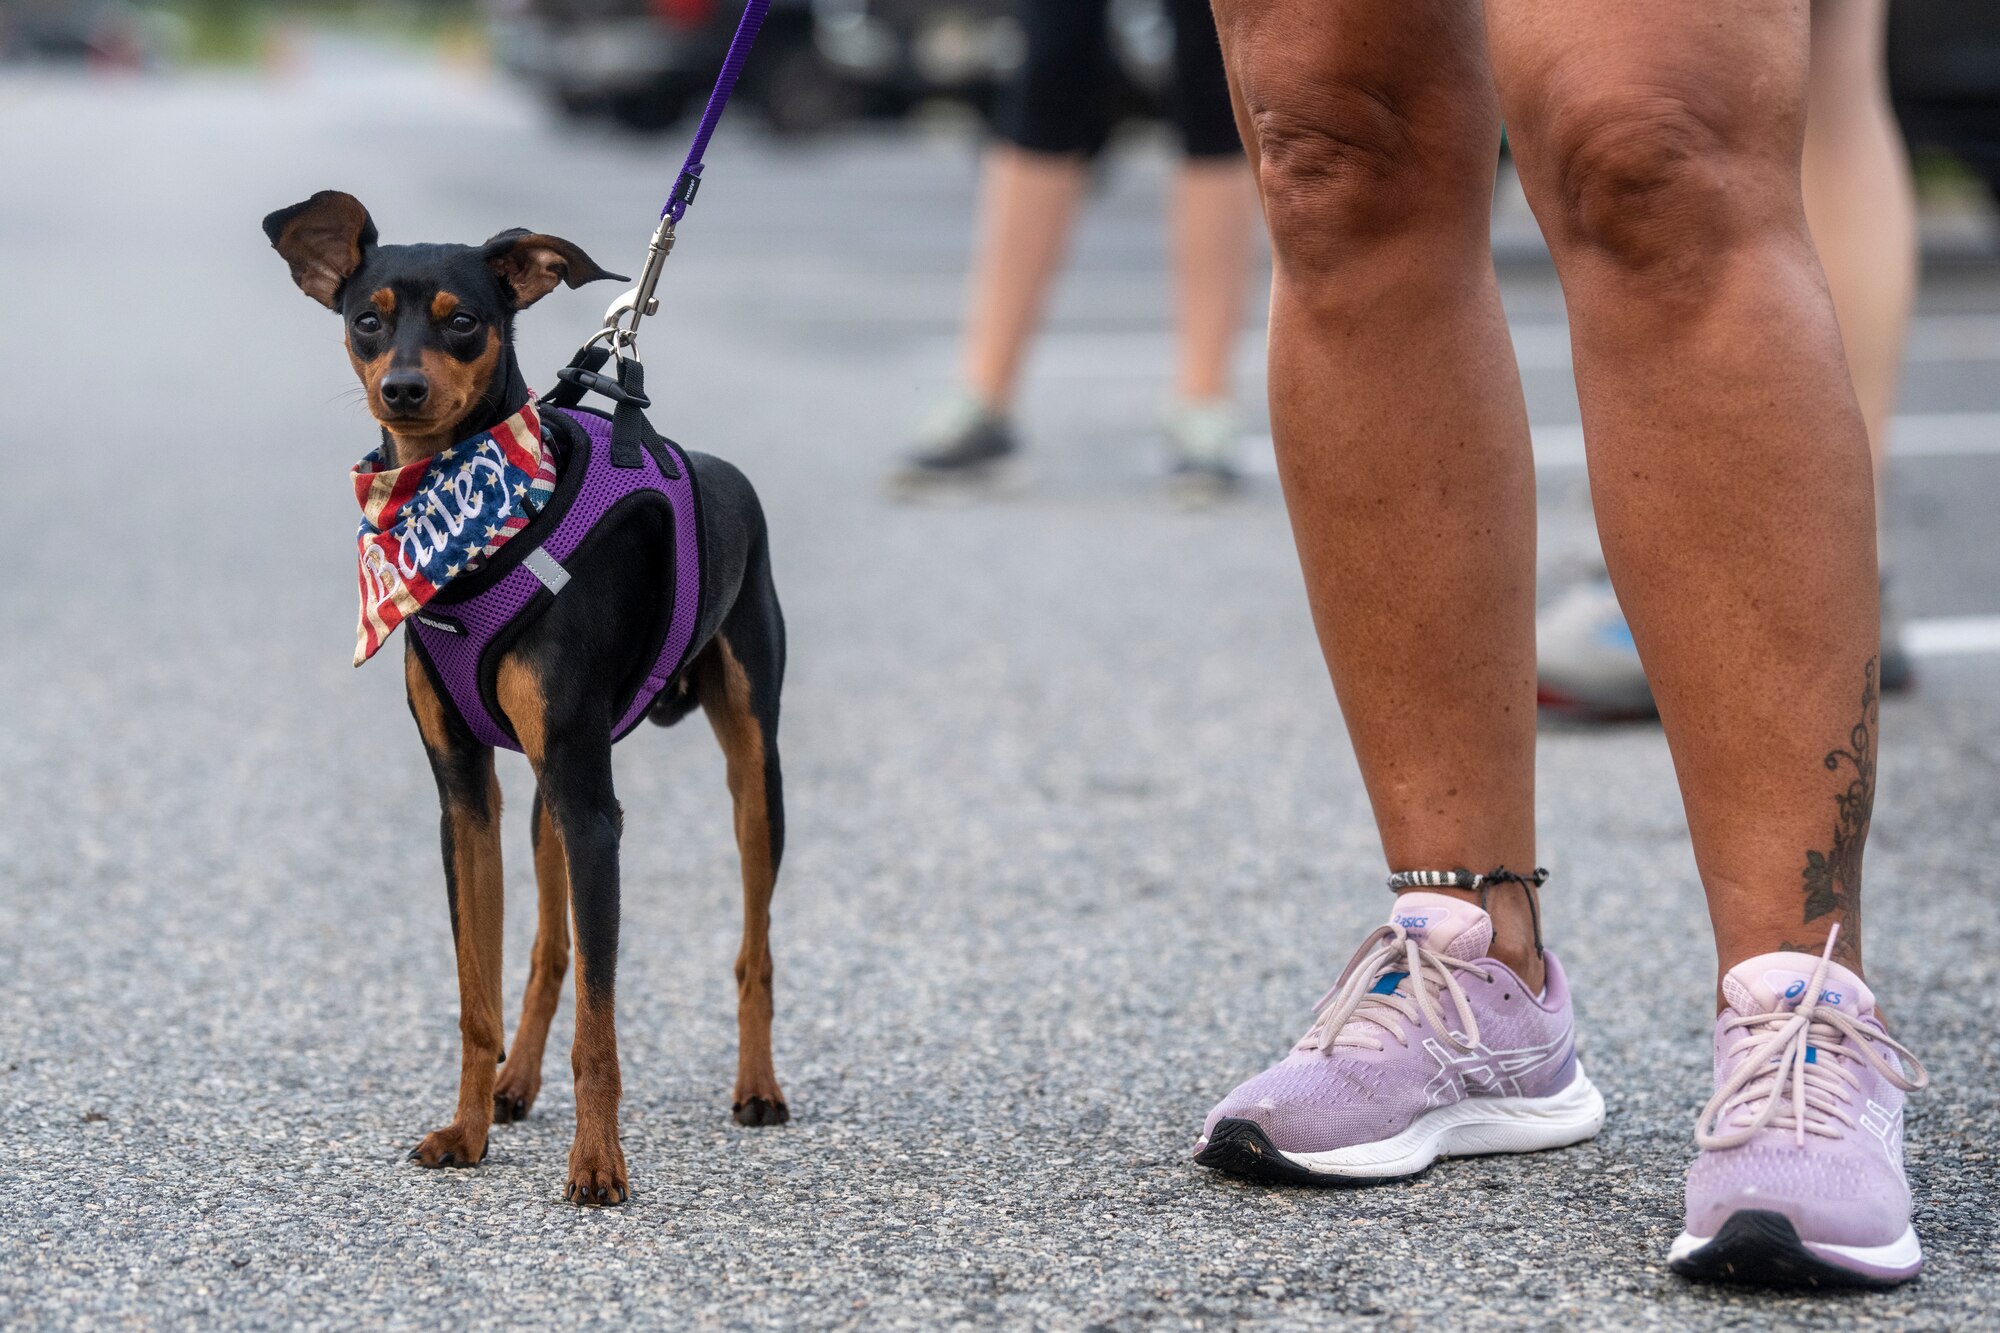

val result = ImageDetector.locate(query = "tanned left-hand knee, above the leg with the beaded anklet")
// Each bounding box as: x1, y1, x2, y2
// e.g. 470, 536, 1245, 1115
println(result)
1250, 82, 1496, 274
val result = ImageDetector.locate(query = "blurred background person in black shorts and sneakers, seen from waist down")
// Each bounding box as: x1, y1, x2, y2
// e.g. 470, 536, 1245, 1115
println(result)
892, 0, 1256, 498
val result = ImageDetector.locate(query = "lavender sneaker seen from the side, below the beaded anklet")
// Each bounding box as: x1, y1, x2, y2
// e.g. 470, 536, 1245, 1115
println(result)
1194, 893, 1604, 1183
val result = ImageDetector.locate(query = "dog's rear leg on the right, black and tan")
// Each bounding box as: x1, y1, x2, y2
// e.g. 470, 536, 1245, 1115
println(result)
698, 620, 792, 1125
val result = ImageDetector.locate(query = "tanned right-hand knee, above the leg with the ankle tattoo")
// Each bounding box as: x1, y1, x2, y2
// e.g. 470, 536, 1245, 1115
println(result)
1522, 90, 1798, 282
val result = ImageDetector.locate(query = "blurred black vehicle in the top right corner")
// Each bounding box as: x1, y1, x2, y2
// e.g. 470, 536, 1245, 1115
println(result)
1888, 0, 2000, 198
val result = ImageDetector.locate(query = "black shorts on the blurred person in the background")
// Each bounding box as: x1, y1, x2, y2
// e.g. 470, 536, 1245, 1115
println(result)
994, 0, 1242, 158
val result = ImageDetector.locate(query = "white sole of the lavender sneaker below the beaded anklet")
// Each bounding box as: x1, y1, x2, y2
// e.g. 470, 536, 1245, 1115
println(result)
1278, 1061, 1604, 1181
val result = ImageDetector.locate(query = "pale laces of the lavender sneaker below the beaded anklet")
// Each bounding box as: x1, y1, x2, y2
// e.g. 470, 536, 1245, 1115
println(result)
1302, 925, 1492, 1051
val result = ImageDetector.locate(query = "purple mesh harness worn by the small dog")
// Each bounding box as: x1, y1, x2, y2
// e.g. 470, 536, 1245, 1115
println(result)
410, 406, 702, 751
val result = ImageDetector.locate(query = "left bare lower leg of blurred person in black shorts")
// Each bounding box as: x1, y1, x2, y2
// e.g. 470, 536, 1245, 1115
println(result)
964, 144, 1086, 410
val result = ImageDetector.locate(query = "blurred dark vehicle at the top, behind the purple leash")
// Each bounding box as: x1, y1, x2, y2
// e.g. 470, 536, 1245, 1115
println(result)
490, 0, 858, 132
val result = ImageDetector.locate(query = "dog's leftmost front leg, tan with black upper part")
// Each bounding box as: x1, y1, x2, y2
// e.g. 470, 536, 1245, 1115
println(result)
404, 650, 504, 1167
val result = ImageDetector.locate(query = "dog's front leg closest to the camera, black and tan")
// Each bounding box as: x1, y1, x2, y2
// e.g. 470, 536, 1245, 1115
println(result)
496, 658, 630, 1205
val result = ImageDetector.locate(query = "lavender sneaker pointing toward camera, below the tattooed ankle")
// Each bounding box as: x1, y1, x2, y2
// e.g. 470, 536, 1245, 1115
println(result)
1668, 928, 1930, 1287
